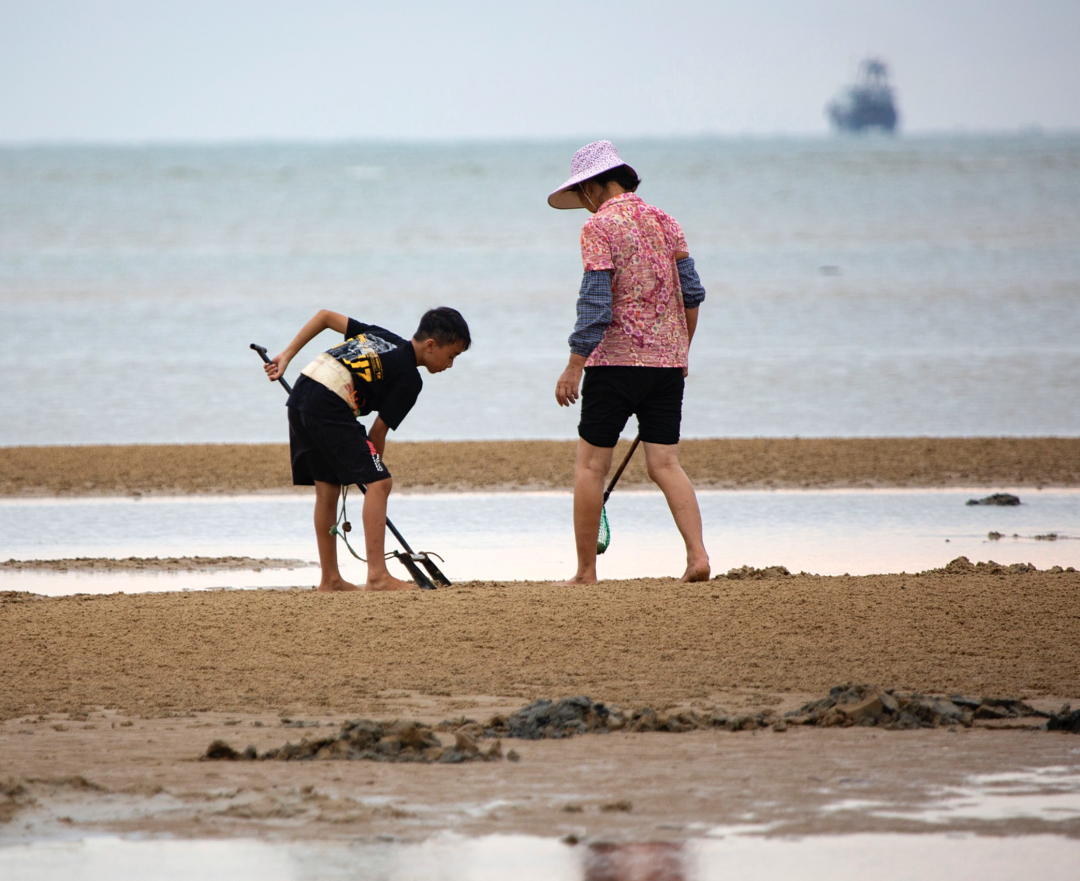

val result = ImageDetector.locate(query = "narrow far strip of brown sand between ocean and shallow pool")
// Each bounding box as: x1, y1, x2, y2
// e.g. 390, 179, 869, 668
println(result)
6, 437, 1080, 497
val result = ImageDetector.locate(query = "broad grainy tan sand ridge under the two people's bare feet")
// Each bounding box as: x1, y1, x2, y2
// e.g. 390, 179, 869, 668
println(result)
0, 567, 1080, 719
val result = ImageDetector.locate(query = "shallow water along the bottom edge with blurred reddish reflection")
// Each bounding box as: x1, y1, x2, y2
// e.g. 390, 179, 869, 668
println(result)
0, 833, 1080, 881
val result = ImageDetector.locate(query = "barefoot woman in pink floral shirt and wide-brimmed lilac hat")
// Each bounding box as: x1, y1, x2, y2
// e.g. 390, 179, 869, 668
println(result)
548, 140, 710, 584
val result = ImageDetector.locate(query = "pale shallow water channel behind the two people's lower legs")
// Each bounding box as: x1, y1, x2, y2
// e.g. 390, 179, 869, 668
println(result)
0, 489, 1080, 595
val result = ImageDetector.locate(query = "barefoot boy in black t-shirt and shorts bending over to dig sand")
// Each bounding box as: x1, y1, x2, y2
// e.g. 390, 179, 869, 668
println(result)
265, 306, 472, 591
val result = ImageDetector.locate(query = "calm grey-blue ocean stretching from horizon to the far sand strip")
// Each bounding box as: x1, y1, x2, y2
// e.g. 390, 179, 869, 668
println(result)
0, 135, 1080, 445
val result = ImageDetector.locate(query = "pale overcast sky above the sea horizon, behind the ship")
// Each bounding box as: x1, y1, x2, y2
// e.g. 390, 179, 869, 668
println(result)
0, 0, 1080, 143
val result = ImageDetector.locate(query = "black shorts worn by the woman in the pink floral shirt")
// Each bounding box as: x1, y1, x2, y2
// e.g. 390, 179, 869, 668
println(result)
578, 367, 686, 447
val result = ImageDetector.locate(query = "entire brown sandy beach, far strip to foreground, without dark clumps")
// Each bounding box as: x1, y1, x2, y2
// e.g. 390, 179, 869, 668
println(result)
0, 438, 1080, 841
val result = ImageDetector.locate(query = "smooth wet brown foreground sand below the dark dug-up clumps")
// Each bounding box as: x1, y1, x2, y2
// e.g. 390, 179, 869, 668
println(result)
0, 713, 1080, 846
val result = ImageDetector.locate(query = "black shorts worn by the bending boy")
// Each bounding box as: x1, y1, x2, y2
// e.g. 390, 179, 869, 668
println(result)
288, 407, 390, 486
